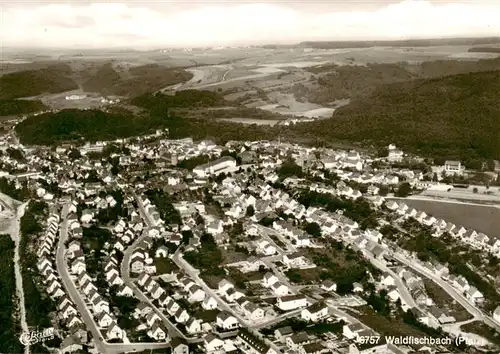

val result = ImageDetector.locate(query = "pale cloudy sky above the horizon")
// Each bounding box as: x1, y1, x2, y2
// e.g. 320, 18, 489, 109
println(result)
0, 0, 500, 49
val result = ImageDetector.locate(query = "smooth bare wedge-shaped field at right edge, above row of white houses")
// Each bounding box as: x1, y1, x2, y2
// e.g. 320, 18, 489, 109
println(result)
392, 199, 500, 239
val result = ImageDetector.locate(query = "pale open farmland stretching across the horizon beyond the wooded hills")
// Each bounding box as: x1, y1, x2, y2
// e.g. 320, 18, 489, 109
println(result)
0, 45, 500, 113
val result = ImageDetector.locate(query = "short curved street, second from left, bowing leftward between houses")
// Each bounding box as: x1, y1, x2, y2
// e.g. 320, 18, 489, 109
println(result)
120, 232, 192, 343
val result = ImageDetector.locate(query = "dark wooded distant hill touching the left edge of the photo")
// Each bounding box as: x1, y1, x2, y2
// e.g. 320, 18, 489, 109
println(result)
0, 67, 78, 100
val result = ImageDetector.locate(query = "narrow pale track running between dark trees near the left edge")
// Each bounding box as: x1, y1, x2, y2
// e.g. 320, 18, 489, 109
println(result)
10, 203, 30, 354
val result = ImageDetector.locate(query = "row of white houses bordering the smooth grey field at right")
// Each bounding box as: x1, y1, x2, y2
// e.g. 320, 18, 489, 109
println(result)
385, 200, 500, 257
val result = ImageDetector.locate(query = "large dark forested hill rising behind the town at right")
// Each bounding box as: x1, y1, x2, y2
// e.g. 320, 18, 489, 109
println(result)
294, 71, 500, 159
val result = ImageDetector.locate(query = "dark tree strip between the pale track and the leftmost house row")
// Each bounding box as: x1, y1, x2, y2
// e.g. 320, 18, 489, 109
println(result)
19, 201, 55, 328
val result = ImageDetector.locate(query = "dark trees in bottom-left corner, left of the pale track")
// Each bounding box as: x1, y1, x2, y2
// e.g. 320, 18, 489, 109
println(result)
0, 235, 23, 353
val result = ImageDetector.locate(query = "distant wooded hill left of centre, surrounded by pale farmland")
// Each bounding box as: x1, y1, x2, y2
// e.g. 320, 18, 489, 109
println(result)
82, 63, 192, 97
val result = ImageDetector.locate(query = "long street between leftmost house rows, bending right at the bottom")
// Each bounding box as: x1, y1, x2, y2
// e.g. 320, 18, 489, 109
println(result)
56, 204, 176, 354
